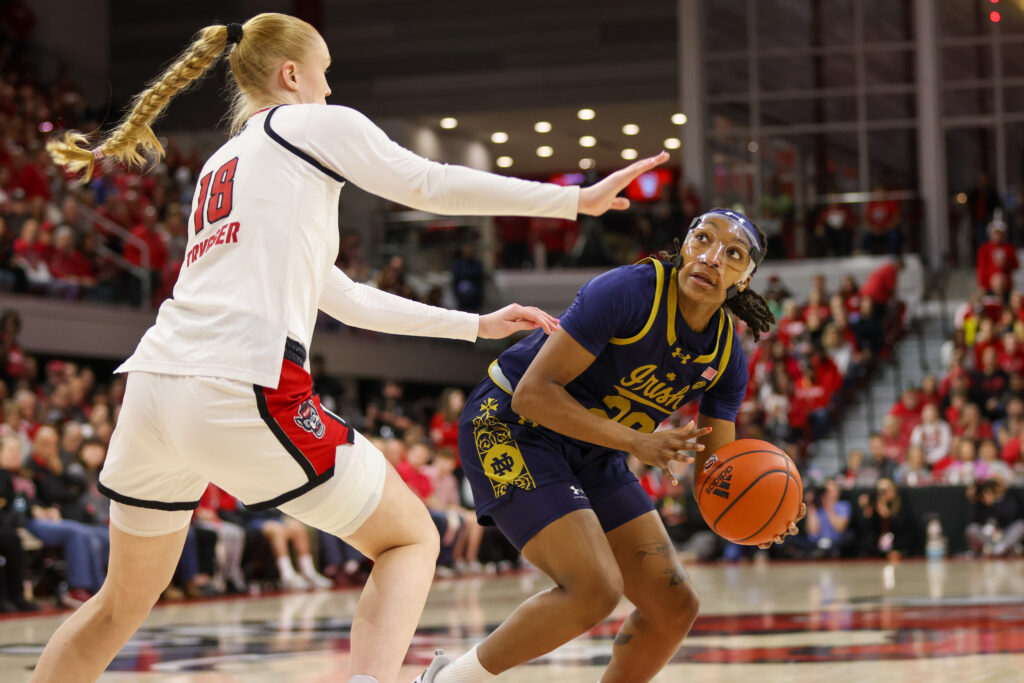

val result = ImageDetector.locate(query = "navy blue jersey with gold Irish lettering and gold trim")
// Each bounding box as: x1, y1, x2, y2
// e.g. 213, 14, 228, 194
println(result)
490, 259, 748, 432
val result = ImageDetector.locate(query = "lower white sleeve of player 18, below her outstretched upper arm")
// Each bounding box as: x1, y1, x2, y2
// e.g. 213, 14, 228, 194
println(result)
319, 267, 480, 342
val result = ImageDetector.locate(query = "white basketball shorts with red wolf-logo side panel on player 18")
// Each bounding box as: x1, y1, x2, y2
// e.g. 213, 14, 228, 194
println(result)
99, 340, 387, 537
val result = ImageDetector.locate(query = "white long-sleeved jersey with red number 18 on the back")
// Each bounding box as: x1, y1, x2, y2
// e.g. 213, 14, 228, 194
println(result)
118, 104, 579, 388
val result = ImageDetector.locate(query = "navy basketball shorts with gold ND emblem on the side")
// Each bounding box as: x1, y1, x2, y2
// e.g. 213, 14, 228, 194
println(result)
459, 379, 654, 550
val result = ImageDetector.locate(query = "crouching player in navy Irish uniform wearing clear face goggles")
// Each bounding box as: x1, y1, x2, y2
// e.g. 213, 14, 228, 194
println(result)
420, 209, 804, 683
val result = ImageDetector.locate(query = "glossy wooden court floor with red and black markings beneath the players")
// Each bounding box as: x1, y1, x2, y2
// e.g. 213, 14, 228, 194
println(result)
0, 560, 1024, 683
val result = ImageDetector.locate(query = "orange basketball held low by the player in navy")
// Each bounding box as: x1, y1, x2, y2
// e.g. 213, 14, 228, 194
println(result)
693, 438, 804, 546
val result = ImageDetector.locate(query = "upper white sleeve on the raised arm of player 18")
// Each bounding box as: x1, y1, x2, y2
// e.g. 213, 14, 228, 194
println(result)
303, 105, 580, 219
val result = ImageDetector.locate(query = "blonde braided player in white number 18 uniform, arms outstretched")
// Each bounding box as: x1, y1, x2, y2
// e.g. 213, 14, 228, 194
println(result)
33, 13, 668, 683
